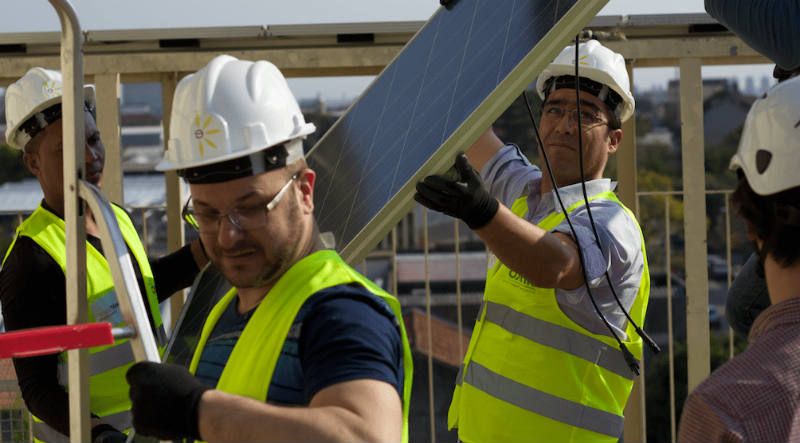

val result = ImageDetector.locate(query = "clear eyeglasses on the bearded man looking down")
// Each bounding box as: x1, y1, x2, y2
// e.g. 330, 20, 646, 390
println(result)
181, 174, 297, 234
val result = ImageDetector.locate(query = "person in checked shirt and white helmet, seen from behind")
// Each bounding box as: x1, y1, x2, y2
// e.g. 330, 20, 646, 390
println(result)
678, 77, 800, 442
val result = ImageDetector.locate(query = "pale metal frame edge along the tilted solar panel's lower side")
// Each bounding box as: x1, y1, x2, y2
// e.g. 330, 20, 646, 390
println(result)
337, 0, 608, 265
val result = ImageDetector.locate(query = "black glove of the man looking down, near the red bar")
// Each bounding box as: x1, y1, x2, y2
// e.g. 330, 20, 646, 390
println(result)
125, 362, 211, 440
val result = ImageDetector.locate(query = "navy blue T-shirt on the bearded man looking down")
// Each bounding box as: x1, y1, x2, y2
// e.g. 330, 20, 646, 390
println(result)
195, 285, 403, 405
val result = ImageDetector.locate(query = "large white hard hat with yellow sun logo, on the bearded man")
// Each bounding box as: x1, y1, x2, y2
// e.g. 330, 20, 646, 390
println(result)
156, 55, 315, 179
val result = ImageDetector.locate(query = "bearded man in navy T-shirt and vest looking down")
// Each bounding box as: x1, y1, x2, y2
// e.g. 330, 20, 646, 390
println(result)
128, 56, 413, 441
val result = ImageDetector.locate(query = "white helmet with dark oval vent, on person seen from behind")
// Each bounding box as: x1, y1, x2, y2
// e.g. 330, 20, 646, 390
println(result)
730, 77, 800, 195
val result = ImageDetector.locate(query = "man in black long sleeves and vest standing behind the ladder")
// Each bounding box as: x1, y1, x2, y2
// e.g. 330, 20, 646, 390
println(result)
0, 68, 206, 442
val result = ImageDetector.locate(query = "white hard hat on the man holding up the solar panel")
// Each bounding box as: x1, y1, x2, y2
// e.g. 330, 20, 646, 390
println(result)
536, 40, 636, 122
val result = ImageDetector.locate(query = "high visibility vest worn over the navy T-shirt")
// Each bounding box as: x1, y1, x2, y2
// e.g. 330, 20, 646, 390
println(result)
189, 250, 414, 442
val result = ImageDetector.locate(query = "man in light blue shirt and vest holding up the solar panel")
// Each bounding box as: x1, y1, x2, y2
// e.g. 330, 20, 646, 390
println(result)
415, 40, 649, 442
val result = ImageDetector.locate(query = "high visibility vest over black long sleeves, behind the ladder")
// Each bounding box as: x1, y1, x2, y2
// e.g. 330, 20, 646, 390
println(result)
3, 205, 163, 443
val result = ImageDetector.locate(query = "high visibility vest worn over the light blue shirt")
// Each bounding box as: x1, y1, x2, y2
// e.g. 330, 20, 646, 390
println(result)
448, 191, 650, 443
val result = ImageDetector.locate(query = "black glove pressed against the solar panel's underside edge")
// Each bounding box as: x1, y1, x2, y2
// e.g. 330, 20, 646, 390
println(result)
414, 152, 499, 229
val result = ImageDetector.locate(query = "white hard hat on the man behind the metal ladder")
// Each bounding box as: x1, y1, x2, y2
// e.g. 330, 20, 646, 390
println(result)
6, 67, 95, 149
